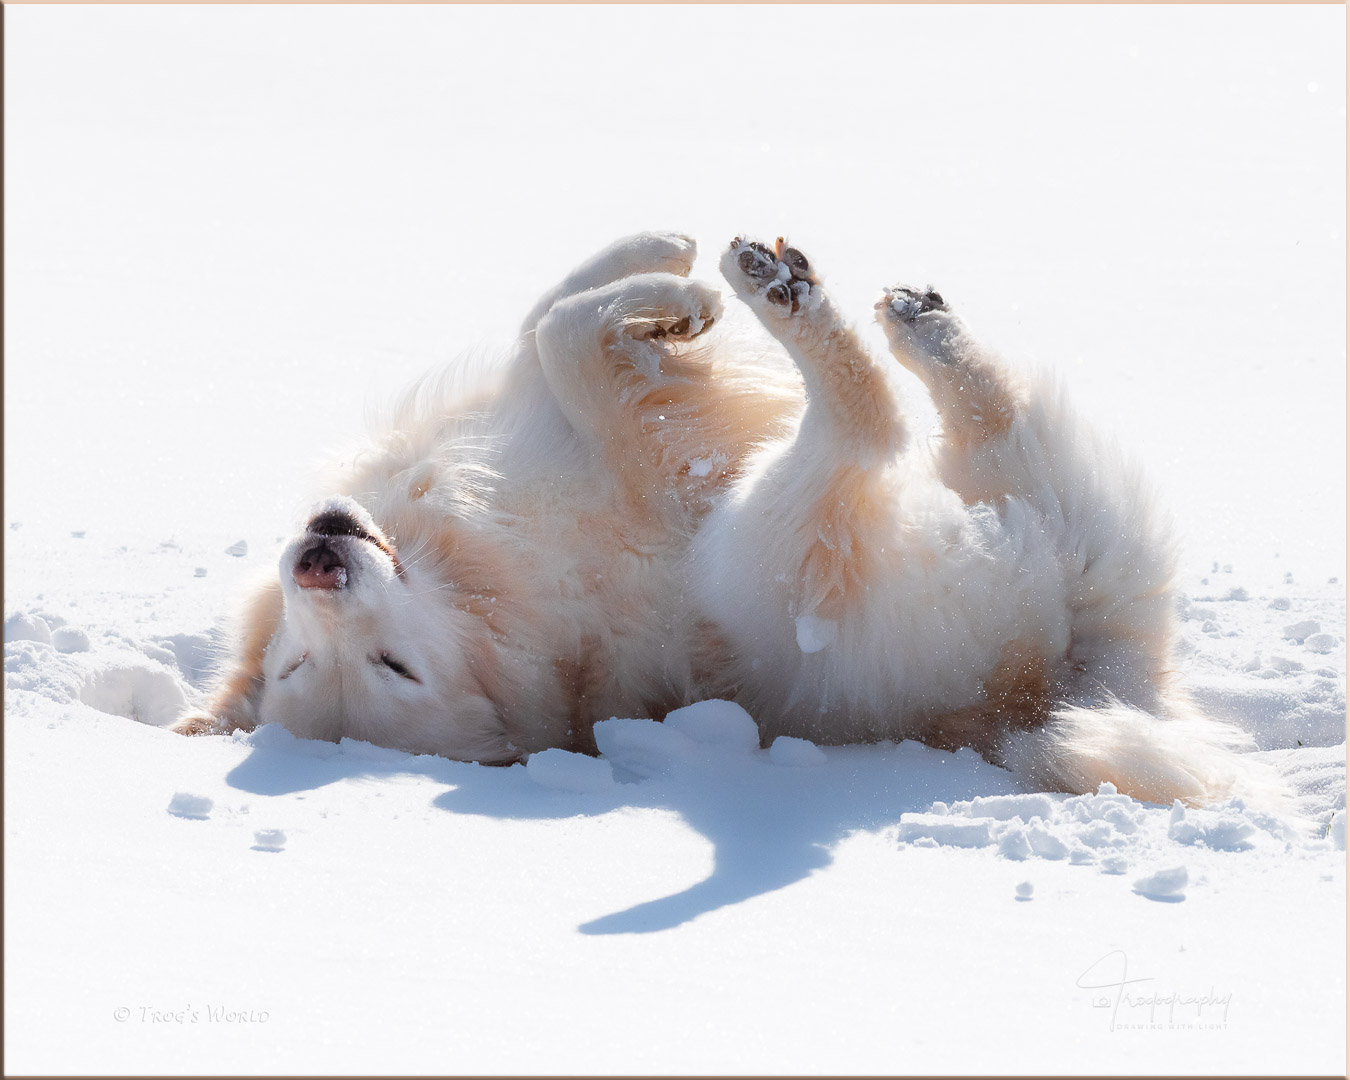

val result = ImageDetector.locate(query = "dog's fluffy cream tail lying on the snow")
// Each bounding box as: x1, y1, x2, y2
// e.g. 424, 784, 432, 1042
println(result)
999, 701, 1285, 810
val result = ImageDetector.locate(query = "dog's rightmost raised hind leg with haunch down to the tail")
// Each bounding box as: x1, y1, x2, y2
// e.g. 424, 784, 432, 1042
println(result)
876, 286, 1188, 756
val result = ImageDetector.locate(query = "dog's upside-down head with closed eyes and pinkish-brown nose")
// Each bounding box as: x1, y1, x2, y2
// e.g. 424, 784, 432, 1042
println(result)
258, 497, 520, 761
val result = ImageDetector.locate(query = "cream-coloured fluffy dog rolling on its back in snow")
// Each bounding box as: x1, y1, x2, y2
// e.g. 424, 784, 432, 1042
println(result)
176, 234, 1258, 802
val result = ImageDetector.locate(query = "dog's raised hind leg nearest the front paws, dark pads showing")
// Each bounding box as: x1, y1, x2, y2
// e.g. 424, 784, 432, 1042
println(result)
702, 238, 906, 637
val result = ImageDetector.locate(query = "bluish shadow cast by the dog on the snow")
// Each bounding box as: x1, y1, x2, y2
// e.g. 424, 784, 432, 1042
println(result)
227, 725, 1017, 934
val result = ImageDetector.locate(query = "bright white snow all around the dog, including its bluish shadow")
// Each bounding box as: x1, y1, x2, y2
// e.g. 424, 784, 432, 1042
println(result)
4, 5, 1346, 1073
